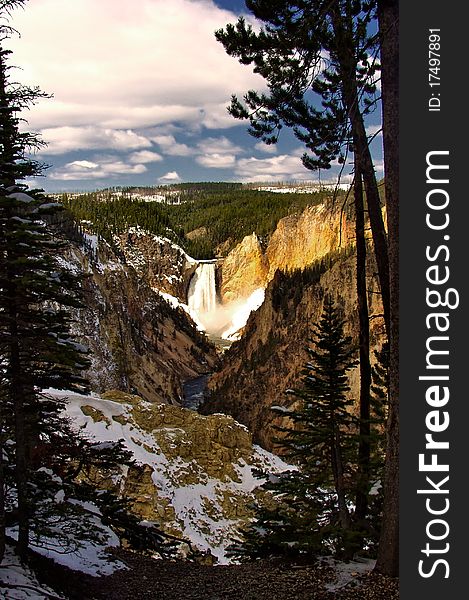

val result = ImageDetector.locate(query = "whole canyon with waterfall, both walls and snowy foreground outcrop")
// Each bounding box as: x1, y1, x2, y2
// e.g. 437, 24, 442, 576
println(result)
63, 192, 384, 562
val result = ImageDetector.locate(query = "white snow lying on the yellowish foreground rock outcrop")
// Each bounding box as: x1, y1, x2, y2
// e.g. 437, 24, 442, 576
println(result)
46, 390, 288, 564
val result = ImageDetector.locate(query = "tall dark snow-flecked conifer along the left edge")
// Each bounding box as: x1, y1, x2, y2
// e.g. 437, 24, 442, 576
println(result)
0, 0, 181, 559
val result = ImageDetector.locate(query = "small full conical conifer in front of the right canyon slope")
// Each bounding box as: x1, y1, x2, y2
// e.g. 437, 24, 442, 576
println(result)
233, 296, 356, 556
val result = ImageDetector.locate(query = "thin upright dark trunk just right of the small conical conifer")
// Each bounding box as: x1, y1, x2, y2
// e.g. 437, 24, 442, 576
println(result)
354, 168, 371, 521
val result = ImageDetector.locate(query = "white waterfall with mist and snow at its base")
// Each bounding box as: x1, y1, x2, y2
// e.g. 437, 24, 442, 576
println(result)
187, 262, 264, 341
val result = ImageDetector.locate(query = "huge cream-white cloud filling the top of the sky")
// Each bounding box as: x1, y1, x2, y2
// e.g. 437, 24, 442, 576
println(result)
8, 0, 265, 150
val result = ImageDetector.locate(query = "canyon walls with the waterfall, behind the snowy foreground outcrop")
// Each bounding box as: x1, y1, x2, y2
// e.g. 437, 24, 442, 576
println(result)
71, 199, 384, 449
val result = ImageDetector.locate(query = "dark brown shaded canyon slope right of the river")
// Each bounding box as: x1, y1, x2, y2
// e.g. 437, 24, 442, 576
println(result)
202, 250, 384, 449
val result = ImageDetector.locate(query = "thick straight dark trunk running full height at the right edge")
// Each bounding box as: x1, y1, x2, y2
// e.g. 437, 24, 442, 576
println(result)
376, 0, 399, 577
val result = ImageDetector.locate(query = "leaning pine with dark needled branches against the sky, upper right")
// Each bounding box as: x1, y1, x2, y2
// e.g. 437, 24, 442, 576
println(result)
215, 0, 390, 332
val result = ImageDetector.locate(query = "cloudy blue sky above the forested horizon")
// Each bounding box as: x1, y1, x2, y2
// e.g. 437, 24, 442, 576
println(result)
6, 0, 382, 191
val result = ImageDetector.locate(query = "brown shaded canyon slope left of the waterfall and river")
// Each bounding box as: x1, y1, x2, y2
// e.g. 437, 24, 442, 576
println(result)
67, 241, 216, 403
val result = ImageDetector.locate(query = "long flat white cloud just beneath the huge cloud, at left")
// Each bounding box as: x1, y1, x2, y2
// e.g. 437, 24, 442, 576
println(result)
42, 126, 152, 155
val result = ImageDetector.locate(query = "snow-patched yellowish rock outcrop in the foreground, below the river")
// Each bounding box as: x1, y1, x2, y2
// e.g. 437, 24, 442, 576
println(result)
59, 391, 286, 561
